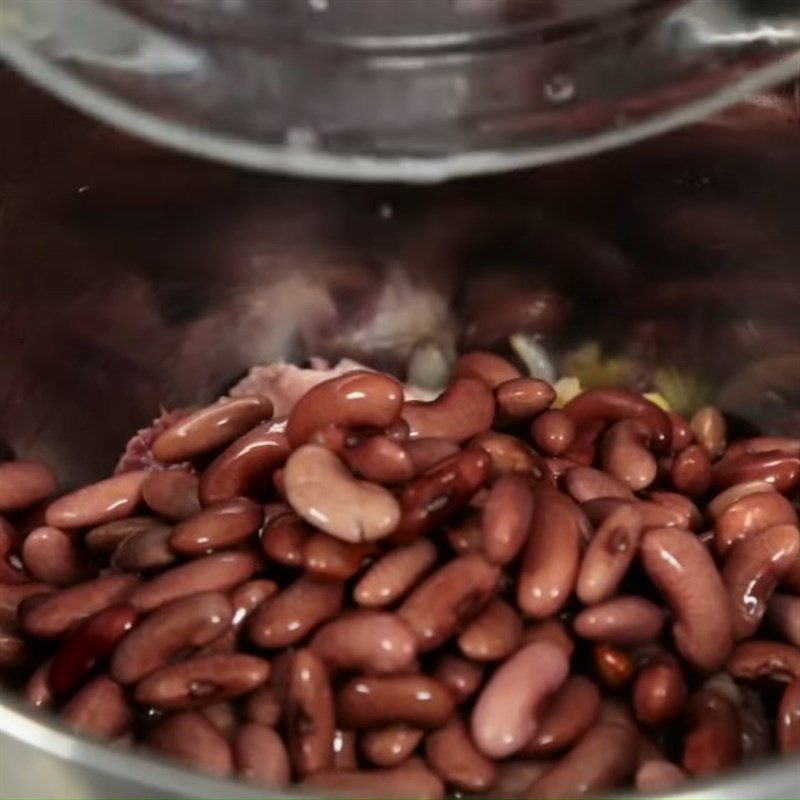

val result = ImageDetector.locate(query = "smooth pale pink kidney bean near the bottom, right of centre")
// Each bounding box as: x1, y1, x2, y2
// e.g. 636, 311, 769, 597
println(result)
471, 642, 569, 758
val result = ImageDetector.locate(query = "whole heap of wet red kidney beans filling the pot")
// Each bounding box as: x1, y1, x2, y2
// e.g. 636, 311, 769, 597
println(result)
0, 352, 800, 798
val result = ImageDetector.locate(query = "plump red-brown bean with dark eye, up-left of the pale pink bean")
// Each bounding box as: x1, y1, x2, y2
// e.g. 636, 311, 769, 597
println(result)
397, 554, 500, 653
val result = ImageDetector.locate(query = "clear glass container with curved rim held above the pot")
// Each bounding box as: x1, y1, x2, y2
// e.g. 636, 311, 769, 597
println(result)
0, 0, 800, 181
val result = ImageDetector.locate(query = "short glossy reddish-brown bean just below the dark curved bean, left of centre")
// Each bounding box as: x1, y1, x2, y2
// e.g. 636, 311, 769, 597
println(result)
169, 497, 264, 556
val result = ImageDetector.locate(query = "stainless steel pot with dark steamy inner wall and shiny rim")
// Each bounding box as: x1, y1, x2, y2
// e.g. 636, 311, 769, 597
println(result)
0, 72, 800, 798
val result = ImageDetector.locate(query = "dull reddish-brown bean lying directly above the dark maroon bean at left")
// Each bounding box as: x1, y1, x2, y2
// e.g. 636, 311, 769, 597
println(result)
21, 575, 138, 638
